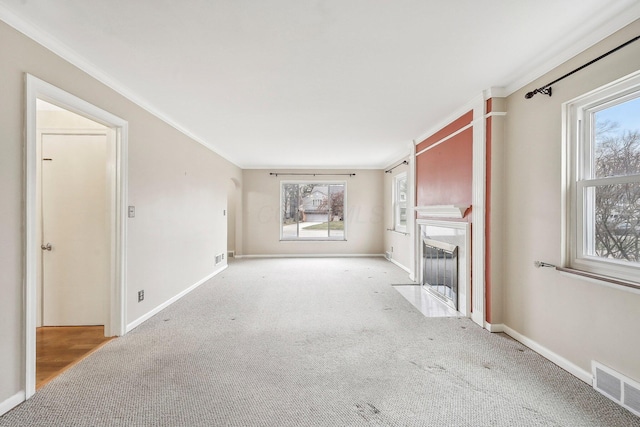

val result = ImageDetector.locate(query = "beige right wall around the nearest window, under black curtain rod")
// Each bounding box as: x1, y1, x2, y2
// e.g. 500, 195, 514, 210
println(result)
503, 22, 640, 381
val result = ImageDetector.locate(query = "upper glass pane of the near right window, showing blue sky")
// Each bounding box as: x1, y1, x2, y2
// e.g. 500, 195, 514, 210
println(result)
592, 98, 640, 178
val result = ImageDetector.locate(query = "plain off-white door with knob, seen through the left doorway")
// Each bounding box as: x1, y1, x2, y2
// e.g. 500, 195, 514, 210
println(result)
42, 134, 110, 326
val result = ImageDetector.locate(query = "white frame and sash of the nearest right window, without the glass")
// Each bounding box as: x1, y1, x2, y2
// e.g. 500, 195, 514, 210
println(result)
563, 71, 640, 283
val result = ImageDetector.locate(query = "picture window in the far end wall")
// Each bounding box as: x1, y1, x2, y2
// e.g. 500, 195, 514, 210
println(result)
280, 182, 347, 240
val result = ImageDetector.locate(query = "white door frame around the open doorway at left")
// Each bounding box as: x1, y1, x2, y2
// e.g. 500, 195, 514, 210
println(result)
24, 74, 129, 399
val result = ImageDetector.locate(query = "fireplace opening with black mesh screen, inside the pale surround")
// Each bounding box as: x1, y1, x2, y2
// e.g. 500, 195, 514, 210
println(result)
422, 238, 458, 310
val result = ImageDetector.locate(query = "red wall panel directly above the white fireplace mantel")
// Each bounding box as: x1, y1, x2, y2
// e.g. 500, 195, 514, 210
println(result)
416, 126, 473, 206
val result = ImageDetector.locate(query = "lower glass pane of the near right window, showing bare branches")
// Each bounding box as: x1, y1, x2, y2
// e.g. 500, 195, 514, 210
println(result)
585, 182, 640, 263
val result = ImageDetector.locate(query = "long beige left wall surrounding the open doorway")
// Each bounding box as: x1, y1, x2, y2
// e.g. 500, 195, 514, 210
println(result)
0, 18, 242, 411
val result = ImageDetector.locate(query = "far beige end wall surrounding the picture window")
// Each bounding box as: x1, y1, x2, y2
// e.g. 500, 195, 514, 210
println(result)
242, 169, 384, 255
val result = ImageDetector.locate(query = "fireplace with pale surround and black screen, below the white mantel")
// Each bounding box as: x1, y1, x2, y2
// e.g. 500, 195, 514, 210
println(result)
416, 219, 471, 316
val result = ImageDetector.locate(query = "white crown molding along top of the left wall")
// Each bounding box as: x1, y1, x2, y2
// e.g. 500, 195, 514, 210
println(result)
0, 5, 241, 167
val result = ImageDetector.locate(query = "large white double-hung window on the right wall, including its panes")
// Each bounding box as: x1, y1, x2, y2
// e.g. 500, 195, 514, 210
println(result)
565, 73, 640, 282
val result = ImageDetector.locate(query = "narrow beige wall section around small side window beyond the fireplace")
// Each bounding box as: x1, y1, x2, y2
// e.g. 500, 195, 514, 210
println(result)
384, 156, 414, 270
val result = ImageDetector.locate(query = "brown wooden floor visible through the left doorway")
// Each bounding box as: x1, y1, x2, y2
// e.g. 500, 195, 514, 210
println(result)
36, 326, 113, 389
